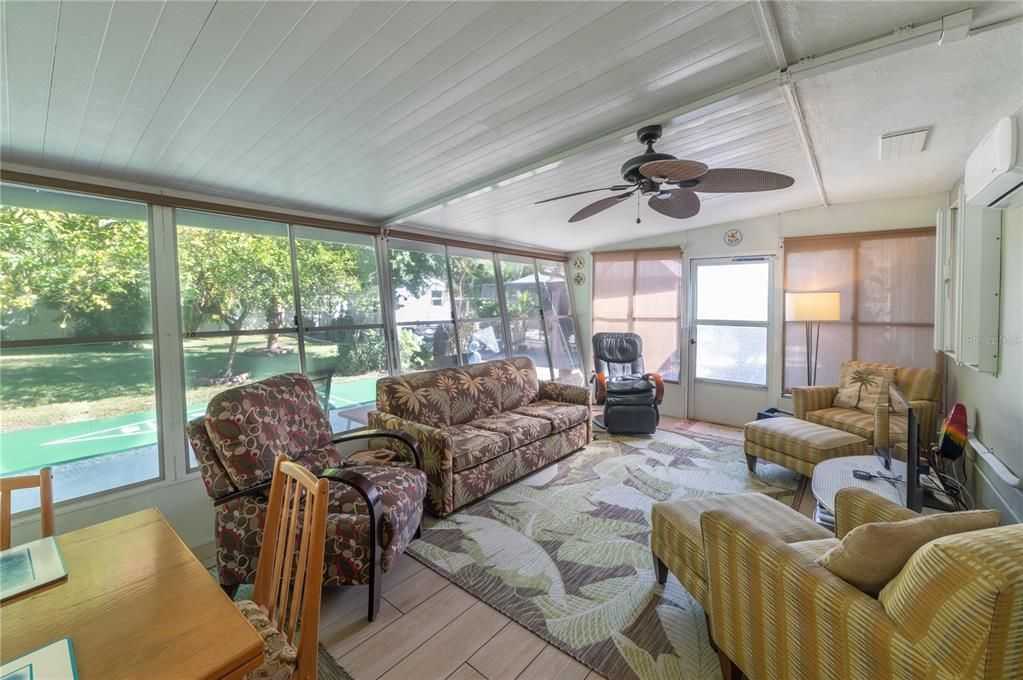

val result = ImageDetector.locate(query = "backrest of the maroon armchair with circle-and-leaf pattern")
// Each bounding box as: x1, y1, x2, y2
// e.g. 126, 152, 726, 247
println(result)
205, 373, 340, 489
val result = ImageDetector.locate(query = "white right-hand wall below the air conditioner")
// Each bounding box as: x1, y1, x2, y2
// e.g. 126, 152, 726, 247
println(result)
945, 201, 1023, 523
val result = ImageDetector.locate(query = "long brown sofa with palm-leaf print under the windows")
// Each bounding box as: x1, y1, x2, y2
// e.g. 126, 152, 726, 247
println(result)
369, 357, 591, 516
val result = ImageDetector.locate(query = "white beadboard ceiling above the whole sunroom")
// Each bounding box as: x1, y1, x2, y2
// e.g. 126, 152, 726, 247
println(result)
0, 0, 1023, 250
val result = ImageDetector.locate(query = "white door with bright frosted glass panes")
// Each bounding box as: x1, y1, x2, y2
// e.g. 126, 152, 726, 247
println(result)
688, 257, 773, 425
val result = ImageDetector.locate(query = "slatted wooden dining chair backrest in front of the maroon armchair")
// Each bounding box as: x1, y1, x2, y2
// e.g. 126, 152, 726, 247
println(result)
253, 455, 328, 678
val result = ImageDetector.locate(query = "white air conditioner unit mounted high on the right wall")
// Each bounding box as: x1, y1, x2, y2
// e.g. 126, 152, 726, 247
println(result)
963, 109, 1023, 208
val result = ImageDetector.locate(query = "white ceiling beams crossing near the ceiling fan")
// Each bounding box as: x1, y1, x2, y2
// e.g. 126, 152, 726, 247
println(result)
383, 6, 973, 225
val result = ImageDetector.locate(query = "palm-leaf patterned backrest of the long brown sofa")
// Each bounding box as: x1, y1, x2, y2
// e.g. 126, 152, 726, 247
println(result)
376, 357, 540, 427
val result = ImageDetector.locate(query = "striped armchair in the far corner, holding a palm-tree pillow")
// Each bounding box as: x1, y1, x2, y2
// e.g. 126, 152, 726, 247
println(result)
792, 361, 941, 449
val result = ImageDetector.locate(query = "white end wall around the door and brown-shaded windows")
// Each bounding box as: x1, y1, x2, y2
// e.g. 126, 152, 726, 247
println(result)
572, 192, 948, 419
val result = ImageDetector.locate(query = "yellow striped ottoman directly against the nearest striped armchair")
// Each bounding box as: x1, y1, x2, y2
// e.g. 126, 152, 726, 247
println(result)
650, 494, 835, 610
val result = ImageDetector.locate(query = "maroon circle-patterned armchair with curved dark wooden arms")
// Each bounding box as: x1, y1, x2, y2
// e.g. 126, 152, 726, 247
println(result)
186, 373, 427, 621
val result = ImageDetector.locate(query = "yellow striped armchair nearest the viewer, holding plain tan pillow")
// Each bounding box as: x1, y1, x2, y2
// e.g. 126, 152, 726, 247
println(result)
702, 488, 1023, 680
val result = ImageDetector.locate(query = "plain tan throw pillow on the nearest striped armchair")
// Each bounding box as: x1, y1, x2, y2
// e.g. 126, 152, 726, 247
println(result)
816, 510, 998, 597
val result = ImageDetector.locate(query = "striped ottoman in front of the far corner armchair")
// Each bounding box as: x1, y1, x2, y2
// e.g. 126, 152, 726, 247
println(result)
743, 418, 874, 477
